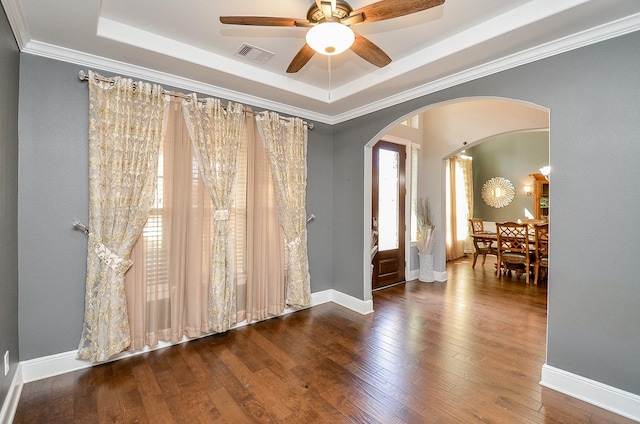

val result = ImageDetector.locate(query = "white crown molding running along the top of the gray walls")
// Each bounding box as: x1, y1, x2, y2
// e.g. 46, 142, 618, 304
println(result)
6, 0, 640, 125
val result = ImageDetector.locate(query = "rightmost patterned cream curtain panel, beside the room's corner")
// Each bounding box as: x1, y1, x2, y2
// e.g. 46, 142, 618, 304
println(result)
256, 112, 311, 308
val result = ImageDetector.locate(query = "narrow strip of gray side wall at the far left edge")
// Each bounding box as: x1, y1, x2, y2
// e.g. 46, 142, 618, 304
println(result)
0, 2, 20, 405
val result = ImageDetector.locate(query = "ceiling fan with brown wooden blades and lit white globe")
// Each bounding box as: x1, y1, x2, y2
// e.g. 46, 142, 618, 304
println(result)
220, 0, 445, 73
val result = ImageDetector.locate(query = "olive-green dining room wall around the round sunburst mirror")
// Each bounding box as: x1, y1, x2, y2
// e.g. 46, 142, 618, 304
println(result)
466, 131, 549, 222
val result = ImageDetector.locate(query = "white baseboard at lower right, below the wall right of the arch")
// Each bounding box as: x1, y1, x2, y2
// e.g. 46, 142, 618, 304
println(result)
540, 364, 640, 422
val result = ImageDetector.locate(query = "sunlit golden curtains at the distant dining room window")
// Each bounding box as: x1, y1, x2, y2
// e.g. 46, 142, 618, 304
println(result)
445, 156, 473, 260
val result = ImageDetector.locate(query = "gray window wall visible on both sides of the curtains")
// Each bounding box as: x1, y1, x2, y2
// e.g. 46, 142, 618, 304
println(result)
19, 54, 333, 360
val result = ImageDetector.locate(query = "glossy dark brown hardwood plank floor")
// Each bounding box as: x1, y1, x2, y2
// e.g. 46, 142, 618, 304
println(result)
14, 258, 632, 424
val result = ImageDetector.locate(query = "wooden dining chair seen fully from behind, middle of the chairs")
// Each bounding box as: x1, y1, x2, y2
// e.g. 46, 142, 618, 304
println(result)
496, 222, 531, 284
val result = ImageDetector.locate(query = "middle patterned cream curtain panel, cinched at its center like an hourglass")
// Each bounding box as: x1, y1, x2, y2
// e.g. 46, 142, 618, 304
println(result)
183, 94, 244, 332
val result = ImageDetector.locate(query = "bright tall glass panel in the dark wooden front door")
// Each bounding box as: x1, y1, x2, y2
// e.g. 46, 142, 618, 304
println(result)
378, 149, 400, 250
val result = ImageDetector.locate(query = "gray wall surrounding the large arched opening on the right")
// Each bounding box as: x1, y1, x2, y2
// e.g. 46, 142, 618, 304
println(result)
333, 32, 640, 395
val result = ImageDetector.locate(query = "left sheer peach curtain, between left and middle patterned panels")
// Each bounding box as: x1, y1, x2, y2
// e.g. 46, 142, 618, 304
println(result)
125, 99, 213, 349
